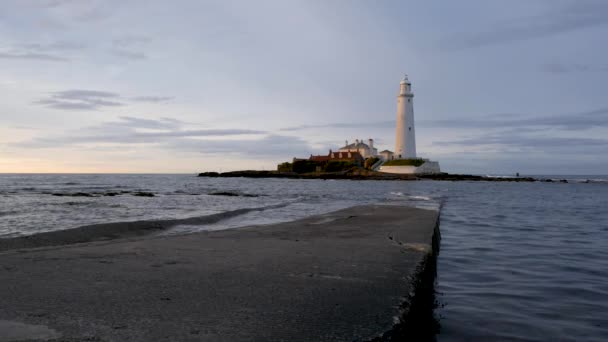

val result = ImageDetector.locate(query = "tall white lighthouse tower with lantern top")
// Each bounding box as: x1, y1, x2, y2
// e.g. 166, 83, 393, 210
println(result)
394, 75, 416, 159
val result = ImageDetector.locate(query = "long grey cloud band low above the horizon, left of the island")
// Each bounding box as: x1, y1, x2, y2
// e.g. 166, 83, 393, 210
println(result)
10, 116, 312, 159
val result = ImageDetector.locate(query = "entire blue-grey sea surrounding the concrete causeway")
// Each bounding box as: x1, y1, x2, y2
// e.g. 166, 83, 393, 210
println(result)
0, 174, 608, 341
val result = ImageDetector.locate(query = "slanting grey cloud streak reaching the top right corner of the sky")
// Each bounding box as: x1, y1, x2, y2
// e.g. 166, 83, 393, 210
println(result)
447, 0, 608, 48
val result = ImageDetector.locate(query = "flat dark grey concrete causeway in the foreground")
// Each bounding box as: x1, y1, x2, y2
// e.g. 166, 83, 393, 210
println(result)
0, 205, 439, 341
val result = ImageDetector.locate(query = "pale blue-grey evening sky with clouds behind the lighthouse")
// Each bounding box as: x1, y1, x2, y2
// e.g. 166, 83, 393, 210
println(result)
0, 0, 608, 175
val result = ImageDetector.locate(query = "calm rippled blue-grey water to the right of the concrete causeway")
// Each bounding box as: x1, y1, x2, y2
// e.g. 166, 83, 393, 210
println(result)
438, 183, 608, 341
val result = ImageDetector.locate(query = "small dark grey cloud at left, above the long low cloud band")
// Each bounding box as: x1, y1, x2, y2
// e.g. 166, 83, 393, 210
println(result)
34, 89, 172, 110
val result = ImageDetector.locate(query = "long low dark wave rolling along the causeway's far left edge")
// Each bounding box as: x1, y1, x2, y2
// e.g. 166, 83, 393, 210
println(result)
0, 203, 291, 252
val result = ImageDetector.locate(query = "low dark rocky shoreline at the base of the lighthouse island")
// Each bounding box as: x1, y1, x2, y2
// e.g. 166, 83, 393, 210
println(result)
198, 170, 548, 183
